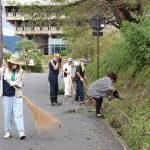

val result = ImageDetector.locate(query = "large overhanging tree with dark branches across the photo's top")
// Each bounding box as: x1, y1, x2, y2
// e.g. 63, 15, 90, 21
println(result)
12, 0, 150, 41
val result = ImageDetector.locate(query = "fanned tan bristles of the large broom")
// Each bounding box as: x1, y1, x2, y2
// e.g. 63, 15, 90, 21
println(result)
23, 96, 61, 133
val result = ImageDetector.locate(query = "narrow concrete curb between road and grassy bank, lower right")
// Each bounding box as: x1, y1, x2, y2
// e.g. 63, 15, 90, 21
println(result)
103, 119, 131, 150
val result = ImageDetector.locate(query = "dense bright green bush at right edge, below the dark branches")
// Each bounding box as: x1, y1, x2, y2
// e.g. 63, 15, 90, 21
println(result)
122, 17, 150, 69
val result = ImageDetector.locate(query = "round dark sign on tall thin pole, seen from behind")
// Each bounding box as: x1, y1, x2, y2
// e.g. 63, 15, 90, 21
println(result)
90, 15, 105, 79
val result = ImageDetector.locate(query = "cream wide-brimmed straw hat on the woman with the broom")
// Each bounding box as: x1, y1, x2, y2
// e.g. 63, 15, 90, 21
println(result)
7, 54, 24, 65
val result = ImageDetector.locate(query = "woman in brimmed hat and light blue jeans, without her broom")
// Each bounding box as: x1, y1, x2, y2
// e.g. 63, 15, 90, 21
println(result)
0, 54, 26, 139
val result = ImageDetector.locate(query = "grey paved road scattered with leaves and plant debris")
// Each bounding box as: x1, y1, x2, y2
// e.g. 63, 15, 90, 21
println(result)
0, 73, 123, 150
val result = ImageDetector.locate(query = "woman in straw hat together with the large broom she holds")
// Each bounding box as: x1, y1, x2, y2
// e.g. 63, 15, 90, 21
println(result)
0, 54, 61, 139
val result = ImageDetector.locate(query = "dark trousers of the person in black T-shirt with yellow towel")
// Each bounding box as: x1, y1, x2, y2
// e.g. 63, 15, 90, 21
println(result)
75, 79, 84, 101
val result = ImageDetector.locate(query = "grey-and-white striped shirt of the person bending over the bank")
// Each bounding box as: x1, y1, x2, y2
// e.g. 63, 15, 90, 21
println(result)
87, 77, 113, 98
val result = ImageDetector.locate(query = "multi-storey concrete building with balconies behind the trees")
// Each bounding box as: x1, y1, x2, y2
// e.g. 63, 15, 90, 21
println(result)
5, 1, 67, 55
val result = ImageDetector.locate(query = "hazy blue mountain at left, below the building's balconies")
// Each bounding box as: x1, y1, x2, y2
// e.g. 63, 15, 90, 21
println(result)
3, 35, 22, 52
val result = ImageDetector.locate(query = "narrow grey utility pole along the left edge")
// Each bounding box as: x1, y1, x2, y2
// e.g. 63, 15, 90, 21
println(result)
0, 0, 3, 66
